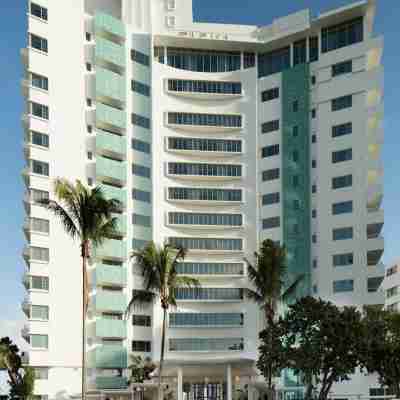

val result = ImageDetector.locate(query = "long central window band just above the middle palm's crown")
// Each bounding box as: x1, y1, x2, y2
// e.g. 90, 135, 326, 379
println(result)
169, 237, 243, 251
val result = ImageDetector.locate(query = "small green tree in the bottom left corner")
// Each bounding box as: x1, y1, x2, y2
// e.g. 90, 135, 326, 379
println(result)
0, 337, 35, 400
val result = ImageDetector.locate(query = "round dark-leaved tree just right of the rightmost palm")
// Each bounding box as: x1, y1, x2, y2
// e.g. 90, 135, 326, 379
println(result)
282, 297, 363, 400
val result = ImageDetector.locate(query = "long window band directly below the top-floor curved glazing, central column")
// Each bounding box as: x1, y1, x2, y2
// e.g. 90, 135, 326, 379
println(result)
168, 79, 242, 94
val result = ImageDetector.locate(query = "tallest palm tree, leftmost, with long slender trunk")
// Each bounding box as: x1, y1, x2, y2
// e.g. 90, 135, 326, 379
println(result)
43, 179, 120, 400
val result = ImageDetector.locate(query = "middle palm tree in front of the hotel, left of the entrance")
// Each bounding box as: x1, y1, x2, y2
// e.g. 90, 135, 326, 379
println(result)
127, 242, 199, 400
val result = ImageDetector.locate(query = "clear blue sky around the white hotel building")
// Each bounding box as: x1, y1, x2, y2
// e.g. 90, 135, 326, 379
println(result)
0, 0, 400, 324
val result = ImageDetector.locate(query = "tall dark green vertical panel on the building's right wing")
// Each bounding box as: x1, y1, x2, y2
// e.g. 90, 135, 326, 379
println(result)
282, 64, 311, 301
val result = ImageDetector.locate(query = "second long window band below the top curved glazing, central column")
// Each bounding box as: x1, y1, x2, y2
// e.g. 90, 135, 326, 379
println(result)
168, 112, 242, 128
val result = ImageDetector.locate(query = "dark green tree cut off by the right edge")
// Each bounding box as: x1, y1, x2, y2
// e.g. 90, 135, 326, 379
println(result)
361, 309, 400, 398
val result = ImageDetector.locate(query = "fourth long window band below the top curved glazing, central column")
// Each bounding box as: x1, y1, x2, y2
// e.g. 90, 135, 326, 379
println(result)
168, 162, 242, 177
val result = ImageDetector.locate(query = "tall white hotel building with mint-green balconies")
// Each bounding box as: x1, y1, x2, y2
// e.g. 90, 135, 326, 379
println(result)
22, 0, 384, 400
